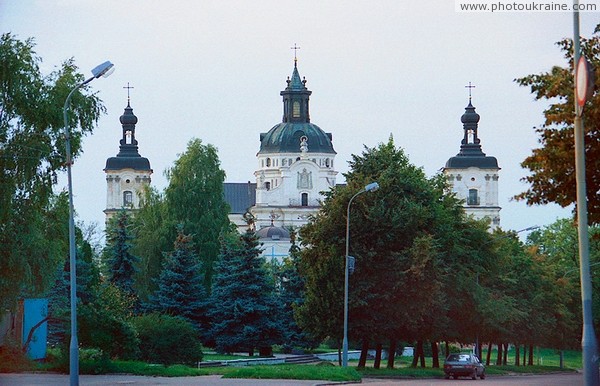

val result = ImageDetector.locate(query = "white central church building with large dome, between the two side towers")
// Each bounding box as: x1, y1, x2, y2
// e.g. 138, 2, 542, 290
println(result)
224, 59, 338, 257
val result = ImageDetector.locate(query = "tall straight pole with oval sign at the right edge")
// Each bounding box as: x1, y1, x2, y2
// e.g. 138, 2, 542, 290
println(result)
573, 5, 600, 386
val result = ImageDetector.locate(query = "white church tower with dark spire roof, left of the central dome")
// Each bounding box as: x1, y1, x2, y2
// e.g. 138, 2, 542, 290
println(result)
104, 96, 152, 222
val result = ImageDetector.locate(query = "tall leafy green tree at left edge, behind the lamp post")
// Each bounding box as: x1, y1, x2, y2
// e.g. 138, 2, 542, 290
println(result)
0, 33, 105, 310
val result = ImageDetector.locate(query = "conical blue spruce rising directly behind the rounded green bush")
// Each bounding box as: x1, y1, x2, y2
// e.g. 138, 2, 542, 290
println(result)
147, 226, 207, 328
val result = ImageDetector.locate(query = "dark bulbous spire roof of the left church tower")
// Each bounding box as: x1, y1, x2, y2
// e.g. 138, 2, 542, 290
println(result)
104, 101, 152, 172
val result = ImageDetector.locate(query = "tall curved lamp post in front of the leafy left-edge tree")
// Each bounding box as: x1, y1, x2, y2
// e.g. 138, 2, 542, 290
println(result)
63, 61, 114, 386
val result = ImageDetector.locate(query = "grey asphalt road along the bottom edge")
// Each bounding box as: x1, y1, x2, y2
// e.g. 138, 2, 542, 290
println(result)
0, 374, 583, 386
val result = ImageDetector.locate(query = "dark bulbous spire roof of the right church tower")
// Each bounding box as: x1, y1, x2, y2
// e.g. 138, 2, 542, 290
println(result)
446, 97, 499, 169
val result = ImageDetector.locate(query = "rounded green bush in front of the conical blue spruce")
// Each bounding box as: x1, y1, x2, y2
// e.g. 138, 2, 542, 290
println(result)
133, 313, 202, 365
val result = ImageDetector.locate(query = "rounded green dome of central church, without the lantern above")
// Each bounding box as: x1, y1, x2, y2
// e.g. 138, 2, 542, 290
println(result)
258, 122, 336, 154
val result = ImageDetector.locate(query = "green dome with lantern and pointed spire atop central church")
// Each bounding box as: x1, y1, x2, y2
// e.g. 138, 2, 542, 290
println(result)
258, 60, 336, 154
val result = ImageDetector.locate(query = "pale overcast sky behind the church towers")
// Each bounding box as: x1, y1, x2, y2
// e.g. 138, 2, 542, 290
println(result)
0, 0, 600, 238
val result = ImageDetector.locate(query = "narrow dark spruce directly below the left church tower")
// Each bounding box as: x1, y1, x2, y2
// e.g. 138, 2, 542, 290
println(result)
105, 210, 139, 299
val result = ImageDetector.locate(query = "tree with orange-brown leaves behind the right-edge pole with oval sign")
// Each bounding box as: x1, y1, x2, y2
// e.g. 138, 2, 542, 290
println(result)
515, 25, 600, 224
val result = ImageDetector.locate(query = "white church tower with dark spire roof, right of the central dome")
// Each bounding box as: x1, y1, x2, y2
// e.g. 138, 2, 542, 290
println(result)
442, 97, 501, 230
